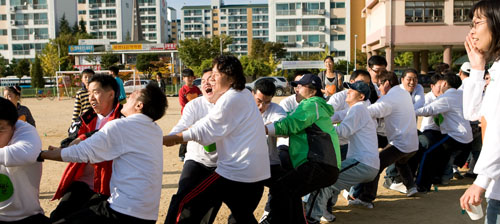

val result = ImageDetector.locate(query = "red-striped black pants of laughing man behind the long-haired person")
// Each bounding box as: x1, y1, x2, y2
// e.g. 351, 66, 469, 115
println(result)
165, 160, 221, 224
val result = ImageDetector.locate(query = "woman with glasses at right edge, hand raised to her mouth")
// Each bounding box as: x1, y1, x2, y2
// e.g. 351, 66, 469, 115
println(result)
460, 0, 500, 224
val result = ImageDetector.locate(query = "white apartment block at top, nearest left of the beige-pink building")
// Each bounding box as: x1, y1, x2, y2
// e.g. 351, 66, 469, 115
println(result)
269, 0, 351, 60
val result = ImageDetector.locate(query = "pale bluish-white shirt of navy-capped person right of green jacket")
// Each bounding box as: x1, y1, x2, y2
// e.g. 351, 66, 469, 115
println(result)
335, 102, 380, 169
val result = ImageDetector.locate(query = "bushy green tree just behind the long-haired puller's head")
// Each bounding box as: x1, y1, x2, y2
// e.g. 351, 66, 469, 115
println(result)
178, 35, 233, 68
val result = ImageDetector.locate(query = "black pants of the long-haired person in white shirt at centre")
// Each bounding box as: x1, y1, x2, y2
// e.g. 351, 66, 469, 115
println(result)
175, 172, 264, 224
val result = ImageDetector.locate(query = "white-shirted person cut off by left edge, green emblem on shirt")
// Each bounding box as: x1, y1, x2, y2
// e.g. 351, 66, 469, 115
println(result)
0, 97, 50, 224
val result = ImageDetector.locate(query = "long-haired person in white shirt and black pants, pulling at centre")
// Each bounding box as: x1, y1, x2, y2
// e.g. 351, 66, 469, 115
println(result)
163, 55, 271, 224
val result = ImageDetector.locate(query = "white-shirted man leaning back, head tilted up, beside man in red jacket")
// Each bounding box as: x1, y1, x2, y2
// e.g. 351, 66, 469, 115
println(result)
40, 84, 167, 224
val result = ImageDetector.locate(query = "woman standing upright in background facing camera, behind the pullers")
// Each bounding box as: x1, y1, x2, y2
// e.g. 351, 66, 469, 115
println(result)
318, 56, 344, 97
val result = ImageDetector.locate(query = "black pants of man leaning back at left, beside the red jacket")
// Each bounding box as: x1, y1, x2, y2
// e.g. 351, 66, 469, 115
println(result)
54, 197, 156, 224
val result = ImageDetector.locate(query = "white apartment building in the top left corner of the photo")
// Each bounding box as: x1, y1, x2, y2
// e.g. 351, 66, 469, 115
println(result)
0, 0, 76, 61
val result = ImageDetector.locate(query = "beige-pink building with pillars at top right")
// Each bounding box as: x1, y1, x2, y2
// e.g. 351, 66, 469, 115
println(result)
362, 0, 477, 74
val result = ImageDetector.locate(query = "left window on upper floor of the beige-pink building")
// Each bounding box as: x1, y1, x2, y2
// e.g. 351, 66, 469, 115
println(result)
405, 1, 444, 23
